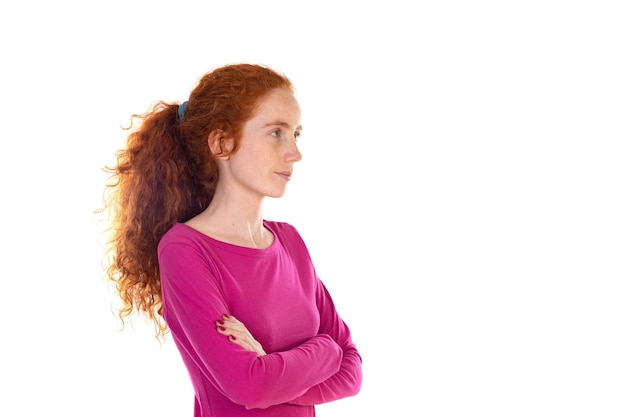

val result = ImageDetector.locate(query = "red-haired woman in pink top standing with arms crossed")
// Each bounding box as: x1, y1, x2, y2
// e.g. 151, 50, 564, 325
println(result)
100, 64, 362, 417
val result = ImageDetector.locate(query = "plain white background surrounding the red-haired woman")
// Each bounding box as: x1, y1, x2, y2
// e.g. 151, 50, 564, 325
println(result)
0, 0, 626, 417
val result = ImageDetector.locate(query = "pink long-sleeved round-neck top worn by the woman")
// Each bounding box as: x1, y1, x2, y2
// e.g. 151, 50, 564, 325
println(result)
159, 221, 362, 417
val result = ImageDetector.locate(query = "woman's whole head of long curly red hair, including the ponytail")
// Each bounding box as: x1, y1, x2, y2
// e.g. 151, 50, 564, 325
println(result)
96, 64, 294, 339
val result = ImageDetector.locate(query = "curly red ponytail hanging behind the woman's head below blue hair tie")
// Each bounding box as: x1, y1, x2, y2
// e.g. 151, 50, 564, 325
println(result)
101, 102, 212, 336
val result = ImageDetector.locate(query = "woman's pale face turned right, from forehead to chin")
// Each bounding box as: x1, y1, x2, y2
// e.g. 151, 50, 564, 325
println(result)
220, 89, 302, 197
